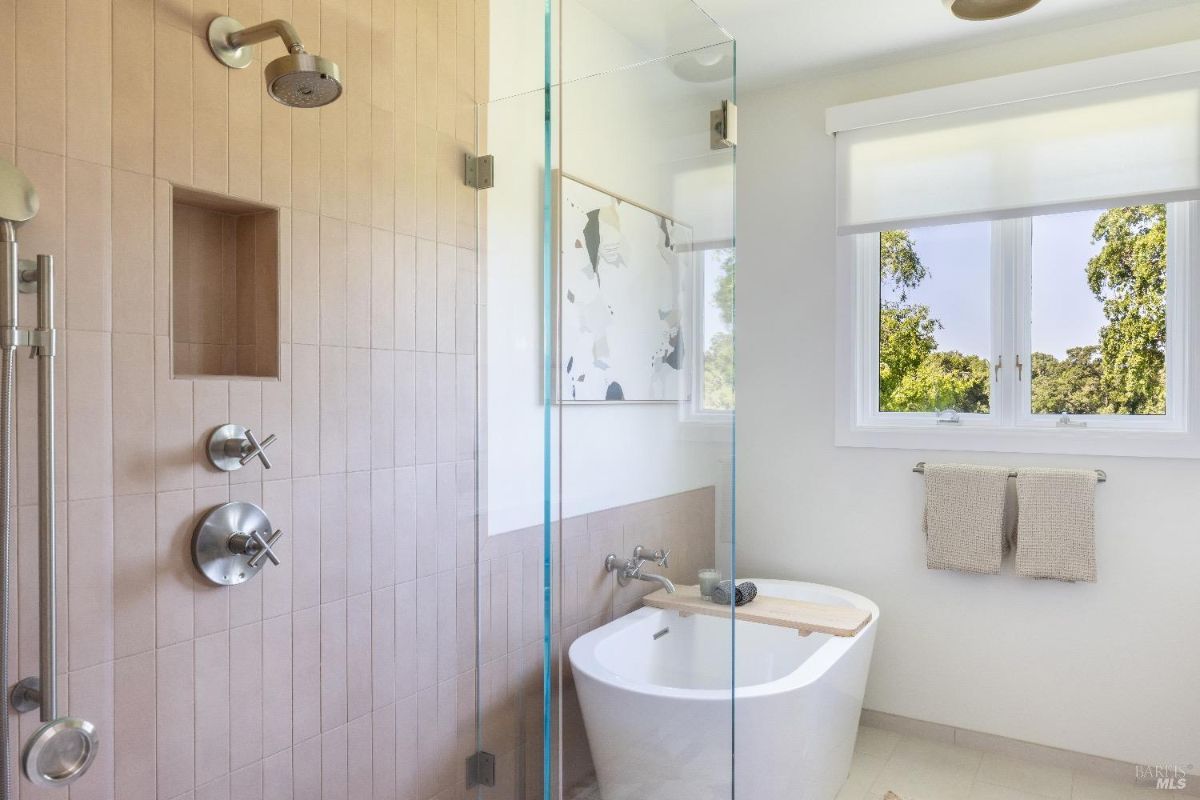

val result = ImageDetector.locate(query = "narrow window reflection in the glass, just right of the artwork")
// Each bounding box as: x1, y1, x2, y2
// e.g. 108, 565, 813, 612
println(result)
692, 246, 737, 419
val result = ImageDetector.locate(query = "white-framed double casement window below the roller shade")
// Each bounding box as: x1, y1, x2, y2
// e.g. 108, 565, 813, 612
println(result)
839, 203, 1200, 457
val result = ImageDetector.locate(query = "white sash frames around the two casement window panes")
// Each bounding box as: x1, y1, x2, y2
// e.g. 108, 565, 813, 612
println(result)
852, 201, 1200, 438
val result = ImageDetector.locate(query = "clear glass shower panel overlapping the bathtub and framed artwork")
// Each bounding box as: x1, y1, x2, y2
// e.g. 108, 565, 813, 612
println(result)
548, 15, 736, 800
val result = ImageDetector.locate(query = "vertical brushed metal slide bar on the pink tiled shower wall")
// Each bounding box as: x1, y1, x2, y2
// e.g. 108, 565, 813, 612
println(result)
35, 255, 59, 722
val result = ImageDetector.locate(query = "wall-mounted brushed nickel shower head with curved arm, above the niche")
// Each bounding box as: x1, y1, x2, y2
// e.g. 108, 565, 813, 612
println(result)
209, 17, 342, 108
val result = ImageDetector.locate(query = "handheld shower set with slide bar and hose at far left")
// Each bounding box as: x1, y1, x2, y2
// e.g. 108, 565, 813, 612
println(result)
0, 160, 100, 800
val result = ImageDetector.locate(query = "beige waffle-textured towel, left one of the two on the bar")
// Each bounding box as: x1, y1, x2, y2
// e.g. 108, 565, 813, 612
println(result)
925, 464, 1008, 575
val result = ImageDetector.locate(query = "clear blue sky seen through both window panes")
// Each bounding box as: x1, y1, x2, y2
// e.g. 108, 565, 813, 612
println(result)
888, 211, 1104, 360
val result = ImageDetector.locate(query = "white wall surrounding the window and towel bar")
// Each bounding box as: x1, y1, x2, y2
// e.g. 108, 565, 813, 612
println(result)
737, 5, 1200, 765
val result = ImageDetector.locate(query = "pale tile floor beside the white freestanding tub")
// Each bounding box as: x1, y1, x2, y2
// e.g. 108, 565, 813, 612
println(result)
566, 726, 1178, 800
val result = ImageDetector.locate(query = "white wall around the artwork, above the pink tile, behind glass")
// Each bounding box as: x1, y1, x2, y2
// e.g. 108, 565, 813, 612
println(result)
481, 0, 733, 545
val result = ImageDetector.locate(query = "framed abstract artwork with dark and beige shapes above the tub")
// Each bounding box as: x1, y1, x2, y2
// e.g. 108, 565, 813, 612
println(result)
558, 175, 692, 403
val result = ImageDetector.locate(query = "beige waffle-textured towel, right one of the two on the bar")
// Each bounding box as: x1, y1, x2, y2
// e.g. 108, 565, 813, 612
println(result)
1016, 469, 1096, 583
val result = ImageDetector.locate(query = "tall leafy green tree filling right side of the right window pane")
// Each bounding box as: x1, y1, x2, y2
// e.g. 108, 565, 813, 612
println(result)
1087, 205, 1166, 414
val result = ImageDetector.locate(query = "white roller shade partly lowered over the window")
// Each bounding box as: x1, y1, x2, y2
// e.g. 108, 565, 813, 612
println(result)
836, 54, 1200, 234
